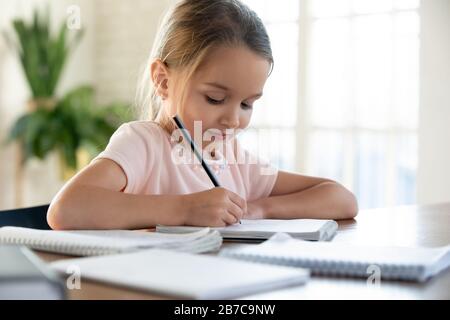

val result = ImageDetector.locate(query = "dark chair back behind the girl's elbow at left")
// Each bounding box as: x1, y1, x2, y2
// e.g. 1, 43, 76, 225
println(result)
0, 204, 51, 230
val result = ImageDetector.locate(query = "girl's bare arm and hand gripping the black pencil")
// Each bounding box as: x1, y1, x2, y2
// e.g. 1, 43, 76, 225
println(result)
47, 159, 247, 229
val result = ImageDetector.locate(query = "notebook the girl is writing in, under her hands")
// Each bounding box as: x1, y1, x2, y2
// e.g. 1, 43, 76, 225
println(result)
156, 219, 338, 241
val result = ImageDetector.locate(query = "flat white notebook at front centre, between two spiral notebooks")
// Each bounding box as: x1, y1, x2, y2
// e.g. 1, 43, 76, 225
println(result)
50, 249, 309, 299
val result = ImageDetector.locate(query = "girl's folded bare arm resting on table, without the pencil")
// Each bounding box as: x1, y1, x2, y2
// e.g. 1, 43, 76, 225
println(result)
248, 171, 358, 219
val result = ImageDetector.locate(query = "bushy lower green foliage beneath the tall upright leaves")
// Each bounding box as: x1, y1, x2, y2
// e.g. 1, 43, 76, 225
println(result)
9, 86, 133, 169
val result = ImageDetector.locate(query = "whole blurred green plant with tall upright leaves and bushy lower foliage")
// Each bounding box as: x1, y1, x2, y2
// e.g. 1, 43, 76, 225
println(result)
3, 9, 133, 179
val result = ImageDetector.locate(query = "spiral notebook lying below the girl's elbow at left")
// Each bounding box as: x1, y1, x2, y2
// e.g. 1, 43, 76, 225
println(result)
0, 227, 222, 256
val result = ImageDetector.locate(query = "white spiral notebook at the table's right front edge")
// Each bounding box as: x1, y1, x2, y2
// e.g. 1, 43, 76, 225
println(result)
220, 234, 450, 282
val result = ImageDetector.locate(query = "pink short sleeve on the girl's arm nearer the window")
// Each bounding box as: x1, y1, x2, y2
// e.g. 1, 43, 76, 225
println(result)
236, 143, 278, 201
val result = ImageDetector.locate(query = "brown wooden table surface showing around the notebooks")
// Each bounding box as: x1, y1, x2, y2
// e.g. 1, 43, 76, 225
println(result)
38, 203, 450, 300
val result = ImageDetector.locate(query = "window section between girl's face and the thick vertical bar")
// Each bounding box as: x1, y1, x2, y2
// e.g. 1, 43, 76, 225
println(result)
240, 0, 299, 170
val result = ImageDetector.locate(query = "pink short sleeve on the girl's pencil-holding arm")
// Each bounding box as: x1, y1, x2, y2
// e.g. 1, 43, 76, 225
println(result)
93, 122, 154, 194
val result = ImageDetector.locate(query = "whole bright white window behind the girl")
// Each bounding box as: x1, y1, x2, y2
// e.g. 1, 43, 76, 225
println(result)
241, 0, 419, 208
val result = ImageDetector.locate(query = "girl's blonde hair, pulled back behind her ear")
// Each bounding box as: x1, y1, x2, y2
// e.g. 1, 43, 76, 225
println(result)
137, 0, 273, 132
